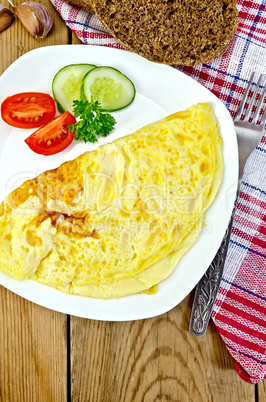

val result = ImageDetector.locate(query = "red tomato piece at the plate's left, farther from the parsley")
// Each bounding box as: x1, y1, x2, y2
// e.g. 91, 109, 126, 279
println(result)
1, 92, 56, 128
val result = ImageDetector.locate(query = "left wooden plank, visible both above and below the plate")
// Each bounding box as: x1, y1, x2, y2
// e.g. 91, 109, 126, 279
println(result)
0, 0, 68, 402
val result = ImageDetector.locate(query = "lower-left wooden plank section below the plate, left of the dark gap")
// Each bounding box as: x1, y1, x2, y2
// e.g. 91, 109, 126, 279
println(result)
0, 287, 67, 402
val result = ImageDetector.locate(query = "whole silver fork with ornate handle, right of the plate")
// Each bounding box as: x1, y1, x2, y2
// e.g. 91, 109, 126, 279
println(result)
189, 73, 266, 336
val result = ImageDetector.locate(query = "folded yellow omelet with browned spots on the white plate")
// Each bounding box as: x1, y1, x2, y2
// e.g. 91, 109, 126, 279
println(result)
0, 103, 223, 299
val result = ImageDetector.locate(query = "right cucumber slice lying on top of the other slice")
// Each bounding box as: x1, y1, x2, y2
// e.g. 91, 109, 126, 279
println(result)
81, 67, 136, 112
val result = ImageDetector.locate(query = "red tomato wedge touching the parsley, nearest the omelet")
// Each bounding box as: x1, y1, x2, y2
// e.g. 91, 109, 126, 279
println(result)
25, 112, 76, 155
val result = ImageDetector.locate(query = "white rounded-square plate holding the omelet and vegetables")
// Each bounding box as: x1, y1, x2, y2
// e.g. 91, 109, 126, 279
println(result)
0, 45, 238, 321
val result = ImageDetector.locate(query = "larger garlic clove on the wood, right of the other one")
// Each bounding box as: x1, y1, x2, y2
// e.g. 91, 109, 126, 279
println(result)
16, 1, 53, 38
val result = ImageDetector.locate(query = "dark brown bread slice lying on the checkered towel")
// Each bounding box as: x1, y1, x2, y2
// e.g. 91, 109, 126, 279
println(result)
65, 0, 238, 65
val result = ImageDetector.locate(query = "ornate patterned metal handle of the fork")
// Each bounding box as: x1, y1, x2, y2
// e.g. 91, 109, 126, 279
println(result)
189, 214, 235, 336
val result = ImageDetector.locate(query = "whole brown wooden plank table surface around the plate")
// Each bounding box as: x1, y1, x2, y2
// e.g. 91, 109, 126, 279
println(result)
0, 0, 266, 402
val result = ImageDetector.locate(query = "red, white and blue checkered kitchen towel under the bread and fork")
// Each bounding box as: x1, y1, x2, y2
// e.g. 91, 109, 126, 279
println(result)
51, 0, 266, 384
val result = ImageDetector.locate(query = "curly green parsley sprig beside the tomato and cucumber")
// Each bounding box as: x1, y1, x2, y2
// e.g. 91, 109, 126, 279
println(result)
68, 100, 116, 142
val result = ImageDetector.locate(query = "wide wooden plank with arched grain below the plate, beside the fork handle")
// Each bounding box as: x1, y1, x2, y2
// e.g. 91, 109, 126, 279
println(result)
71, 296, 255, 402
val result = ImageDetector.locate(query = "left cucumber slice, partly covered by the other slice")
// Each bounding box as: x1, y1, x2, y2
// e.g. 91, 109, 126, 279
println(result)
52, 64, 96, 113
